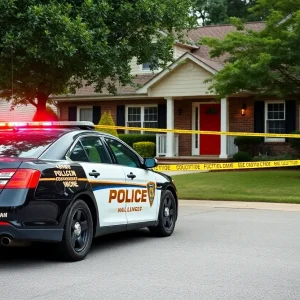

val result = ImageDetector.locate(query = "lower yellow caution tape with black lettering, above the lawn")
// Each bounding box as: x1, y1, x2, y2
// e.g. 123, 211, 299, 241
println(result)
153, 160, 300, 172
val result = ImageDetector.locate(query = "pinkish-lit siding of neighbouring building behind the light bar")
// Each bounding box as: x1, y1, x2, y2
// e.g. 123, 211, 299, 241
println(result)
0, 99, 57, 122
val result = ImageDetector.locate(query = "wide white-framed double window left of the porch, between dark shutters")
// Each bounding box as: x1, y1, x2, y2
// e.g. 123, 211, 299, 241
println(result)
126, 106, 158, 133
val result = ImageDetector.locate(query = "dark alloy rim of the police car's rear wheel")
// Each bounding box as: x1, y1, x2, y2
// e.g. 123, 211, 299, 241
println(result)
71, 209, 90, 252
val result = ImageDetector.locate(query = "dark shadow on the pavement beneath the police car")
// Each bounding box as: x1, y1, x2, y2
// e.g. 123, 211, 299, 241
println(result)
0, 229, 151, 264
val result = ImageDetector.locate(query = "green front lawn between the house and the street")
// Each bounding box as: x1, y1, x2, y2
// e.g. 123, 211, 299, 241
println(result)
173, 170, 300, 203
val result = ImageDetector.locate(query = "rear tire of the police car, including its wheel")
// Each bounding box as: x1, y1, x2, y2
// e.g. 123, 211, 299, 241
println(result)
58, 200, 93, 261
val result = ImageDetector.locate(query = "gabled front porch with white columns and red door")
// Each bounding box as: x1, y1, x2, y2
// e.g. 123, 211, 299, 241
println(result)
137, 53, 237, 160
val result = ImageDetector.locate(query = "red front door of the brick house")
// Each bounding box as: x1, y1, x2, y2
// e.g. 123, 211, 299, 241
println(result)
199, 104, 221, 155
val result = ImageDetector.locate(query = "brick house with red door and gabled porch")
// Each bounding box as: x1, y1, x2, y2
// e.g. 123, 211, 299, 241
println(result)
53, 22, 299, 159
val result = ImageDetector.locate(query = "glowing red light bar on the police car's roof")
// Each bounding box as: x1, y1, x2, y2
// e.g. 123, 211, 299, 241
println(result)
0, 121, 95, 128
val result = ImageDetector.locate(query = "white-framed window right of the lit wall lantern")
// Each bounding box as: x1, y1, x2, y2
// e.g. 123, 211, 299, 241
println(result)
266, 102, 285, 141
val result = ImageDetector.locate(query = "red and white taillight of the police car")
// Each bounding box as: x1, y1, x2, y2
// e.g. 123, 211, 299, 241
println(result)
0, 169, 41, 189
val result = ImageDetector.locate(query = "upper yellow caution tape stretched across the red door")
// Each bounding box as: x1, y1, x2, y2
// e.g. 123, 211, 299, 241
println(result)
95, 125, 300, 139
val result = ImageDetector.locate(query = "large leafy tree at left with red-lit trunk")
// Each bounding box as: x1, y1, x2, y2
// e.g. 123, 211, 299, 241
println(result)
0, 0, 195, 118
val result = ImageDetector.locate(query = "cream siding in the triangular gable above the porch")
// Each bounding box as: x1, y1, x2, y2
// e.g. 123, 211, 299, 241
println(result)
148, 60, 211, 97
